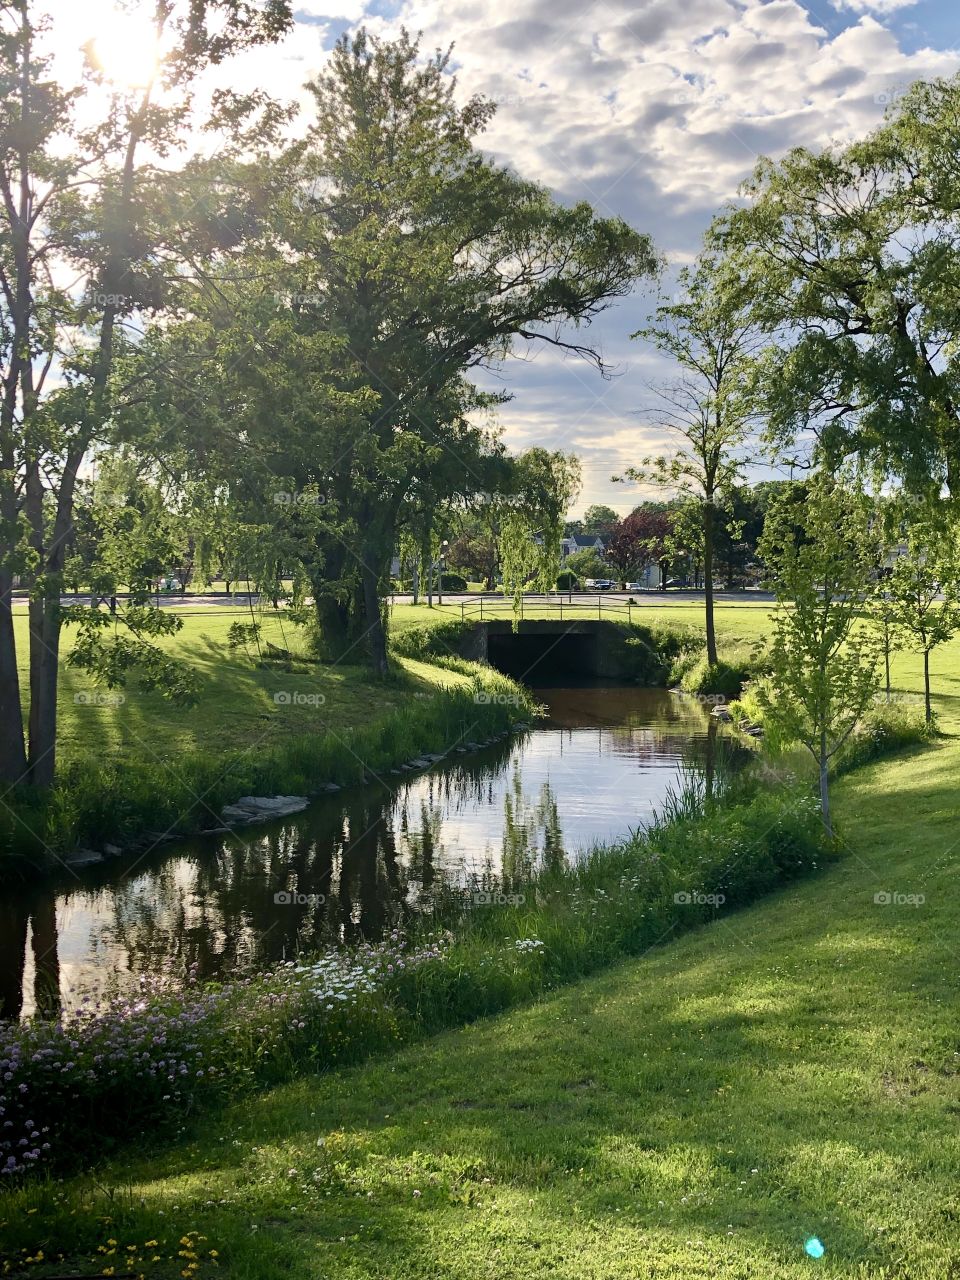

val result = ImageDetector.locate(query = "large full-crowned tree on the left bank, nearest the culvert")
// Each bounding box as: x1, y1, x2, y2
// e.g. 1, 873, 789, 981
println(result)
284, 31, 655, 671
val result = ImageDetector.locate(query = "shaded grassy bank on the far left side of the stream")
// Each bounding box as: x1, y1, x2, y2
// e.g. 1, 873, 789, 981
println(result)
0, 609, 529, 876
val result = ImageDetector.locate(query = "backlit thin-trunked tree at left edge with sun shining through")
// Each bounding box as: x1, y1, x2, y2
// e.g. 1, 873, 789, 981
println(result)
0, 0, 292, 786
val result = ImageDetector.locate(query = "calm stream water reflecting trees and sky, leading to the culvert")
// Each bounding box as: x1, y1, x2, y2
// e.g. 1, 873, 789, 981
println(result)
0, 689, 737, 1016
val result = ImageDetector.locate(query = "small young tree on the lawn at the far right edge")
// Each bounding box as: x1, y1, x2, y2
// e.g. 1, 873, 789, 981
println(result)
886, 508, 960, 724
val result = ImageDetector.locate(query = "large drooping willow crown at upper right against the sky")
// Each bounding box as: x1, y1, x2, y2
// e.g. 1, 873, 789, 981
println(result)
716, 77, 960, 495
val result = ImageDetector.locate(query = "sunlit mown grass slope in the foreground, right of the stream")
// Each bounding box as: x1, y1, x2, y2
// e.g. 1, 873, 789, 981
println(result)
5, 606, 960, 1280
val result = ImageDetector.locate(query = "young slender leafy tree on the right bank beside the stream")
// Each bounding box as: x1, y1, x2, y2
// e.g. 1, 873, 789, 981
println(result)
756, 474, 879, 837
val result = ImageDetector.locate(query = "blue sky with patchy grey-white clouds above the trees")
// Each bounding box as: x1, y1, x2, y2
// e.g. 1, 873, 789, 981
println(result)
51, 0, 960, 512
